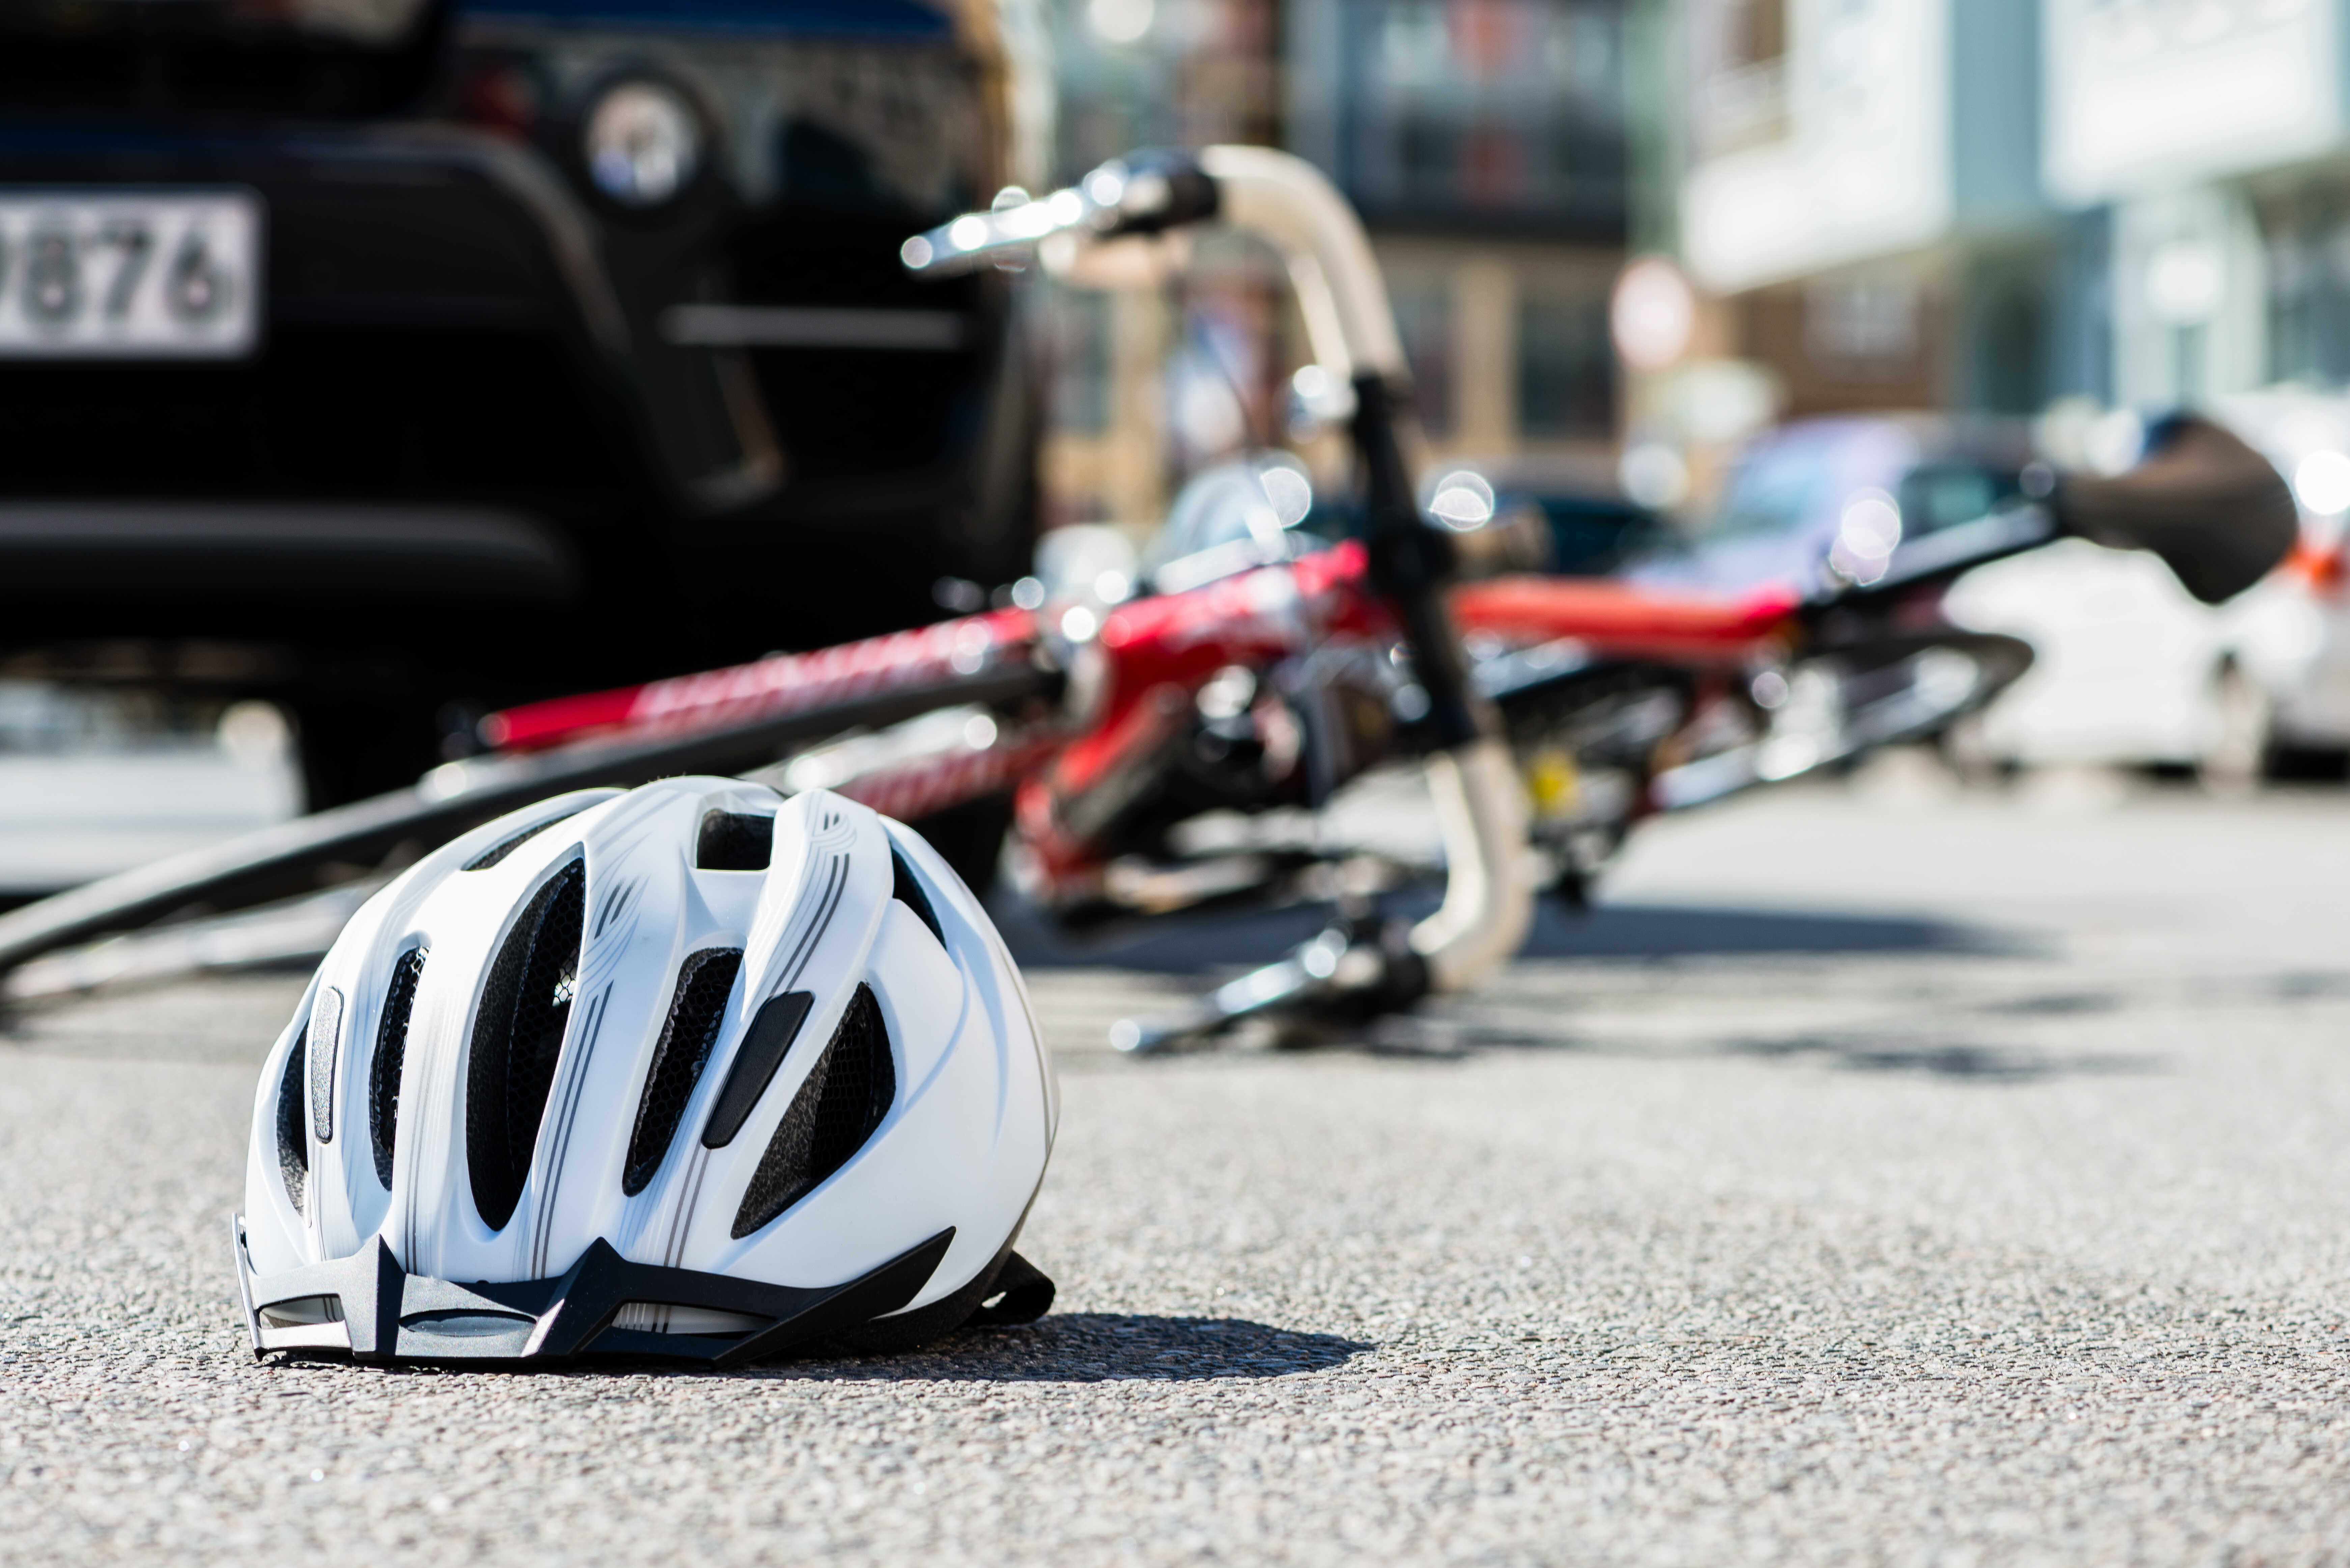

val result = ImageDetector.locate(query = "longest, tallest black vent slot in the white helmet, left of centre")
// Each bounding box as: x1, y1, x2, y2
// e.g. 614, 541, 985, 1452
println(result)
465, 860, 588, 1229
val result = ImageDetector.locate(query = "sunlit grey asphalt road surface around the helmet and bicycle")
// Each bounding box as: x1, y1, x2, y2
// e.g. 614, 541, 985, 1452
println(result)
0, 790, 2350, 1568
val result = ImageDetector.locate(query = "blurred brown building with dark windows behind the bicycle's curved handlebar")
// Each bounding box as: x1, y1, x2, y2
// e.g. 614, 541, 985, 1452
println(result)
1048, 0, 1626, 522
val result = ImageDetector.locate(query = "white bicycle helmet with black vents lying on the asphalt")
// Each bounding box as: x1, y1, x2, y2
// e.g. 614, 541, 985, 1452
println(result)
237, 778, 1060, 1366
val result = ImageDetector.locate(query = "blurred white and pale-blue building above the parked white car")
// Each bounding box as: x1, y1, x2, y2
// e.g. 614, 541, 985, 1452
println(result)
1673, 0, 2350, 451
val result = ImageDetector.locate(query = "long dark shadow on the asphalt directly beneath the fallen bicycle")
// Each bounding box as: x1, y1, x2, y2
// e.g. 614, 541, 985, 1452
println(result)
992, 893, 2026, 976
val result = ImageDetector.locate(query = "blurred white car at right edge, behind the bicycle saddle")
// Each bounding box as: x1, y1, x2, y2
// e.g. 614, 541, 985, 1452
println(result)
1943, 390, 2350, 783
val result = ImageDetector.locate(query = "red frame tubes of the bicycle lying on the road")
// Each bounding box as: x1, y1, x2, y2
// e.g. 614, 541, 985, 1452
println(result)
482, 541, 1795, 884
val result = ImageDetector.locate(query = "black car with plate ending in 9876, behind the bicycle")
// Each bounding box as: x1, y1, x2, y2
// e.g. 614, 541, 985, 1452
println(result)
0, 0, 1039, 806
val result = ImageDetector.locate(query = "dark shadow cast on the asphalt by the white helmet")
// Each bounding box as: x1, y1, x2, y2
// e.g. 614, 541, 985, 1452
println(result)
771, 1312, 1372, 1382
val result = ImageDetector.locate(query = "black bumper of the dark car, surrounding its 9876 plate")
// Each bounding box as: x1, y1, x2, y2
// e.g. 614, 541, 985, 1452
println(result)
0, 118, 1003, 682
